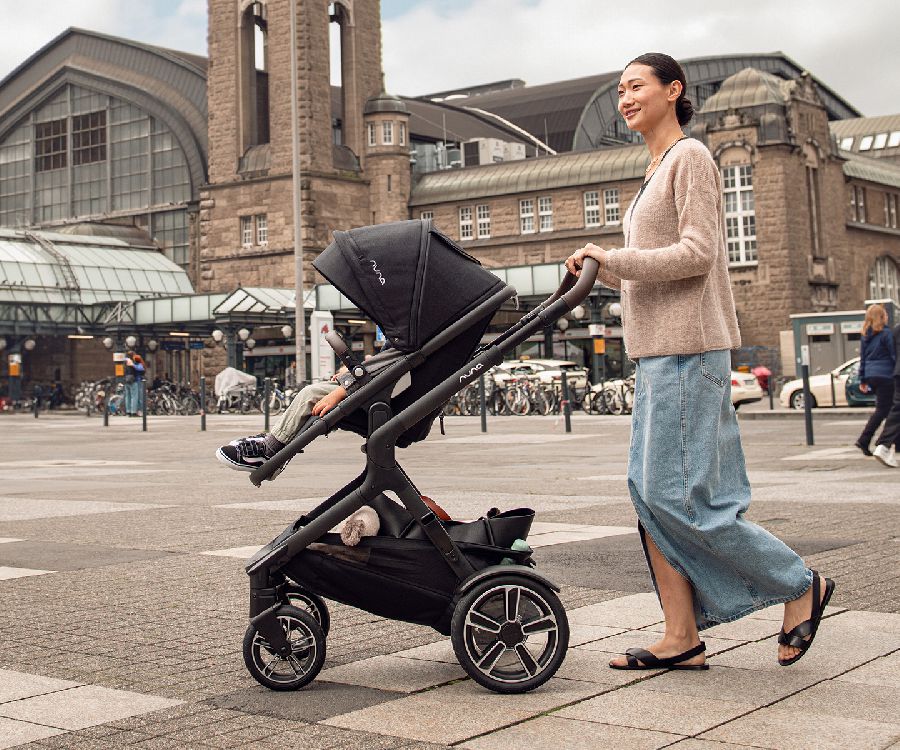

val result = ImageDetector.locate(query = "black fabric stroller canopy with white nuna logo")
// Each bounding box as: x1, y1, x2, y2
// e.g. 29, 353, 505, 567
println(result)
313, 219, 503, 352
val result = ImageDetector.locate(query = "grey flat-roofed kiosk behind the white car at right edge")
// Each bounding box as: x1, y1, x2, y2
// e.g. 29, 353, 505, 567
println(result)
785, 300, 896, 375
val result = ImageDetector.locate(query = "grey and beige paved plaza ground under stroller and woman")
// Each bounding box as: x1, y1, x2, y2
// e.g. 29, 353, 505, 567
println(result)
0, 409, 900, 750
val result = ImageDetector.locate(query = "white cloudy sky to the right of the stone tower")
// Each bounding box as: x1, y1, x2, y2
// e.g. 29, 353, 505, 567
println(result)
383, 0, 900, 115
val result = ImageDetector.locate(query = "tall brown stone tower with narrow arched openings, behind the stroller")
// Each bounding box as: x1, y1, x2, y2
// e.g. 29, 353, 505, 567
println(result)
198, 0, 386, 291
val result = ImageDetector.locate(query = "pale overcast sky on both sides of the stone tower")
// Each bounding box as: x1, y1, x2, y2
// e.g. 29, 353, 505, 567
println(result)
0, 0, 900, 115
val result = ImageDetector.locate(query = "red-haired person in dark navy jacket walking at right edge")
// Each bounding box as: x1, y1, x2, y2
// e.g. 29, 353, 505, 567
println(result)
856, 304, 897, 456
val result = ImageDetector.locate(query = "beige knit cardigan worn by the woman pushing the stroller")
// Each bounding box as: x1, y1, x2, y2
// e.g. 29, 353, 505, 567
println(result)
598, 138, 741, 359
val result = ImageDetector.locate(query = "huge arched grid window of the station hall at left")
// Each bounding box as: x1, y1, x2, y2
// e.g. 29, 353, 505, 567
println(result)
0, 85, 191, 265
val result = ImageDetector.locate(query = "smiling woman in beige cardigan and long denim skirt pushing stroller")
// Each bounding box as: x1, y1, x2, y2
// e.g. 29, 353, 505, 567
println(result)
566, 53, 834, 669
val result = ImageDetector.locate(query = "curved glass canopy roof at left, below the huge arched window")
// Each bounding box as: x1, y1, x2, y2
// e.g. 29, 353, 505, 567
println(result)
0, 229, 194, 305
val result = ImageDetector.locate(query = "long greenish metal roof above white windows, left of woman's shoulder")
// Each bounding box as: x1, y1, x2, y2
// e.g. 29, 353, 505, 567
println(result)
409, 145, 647, 206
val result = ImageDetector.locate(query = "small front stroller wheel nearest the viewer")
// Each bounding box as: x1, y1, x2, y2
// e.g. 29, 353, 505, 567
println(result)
244, 605, 325, 690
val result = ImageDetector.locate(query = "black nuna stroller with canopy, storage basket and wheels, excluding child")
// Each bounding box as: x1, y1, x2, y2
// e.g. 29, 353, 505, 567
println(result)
243, 219, 597, 693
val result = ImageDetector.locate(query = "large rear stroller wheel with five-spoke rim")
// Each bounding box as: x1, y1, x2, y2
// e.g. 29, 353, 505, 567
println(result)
450, 574, 569, 693
